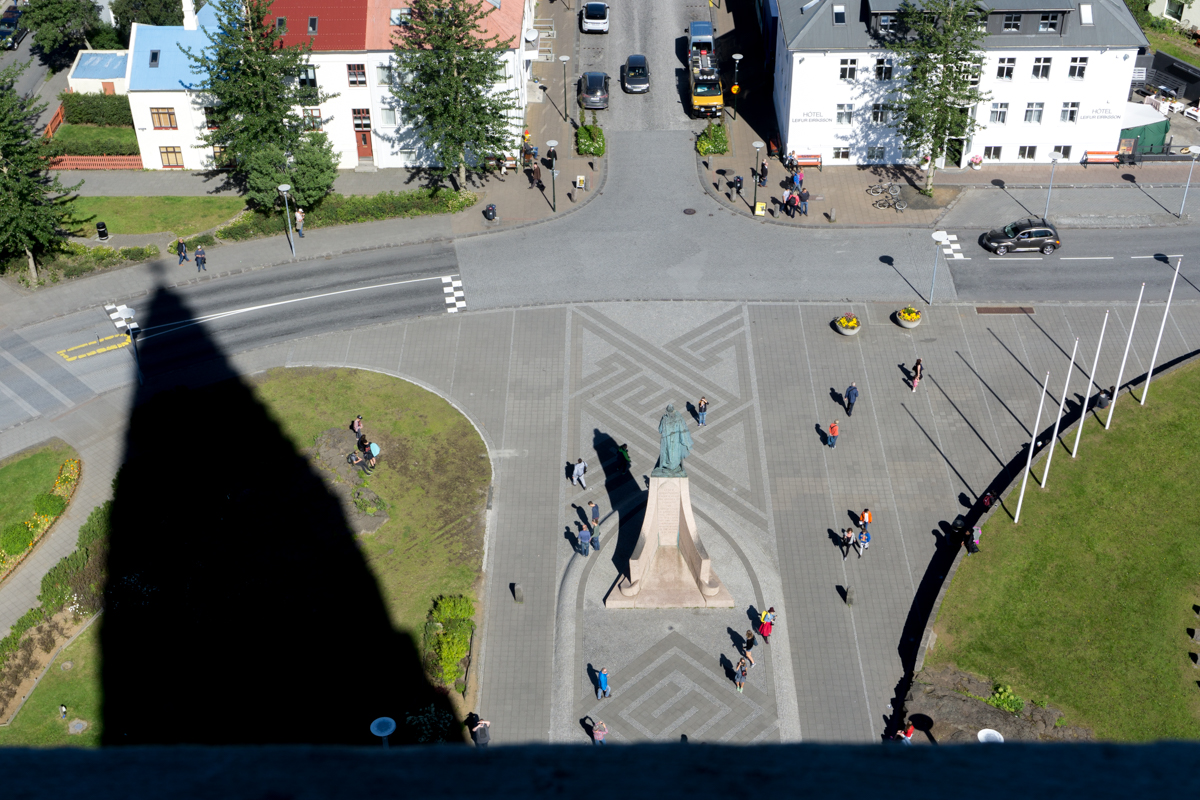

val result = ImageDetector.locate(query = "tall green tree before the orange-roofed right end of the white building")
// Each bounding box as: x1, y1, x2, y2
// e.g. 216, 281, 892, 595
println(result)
391, 0, 517, 186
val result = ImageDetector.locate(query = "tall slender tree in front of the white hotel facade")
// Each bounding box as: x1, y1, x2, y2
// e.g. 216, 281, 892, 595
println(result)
887, 0, 990, 193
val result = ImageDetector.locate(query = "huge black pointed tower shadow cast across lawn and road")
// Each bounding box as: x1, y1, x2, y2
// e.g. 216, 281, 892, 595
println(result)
101, 278, 451, 745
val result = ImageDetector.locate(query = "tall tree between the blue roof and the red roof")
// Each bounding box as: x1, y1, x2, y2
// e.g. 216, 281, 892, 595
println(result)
180, 0, 336, 183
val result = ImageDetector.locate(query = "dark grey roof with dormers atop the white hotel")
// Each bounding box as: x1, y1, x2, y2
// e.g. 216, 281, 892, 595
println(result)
779, 0, 1150, 50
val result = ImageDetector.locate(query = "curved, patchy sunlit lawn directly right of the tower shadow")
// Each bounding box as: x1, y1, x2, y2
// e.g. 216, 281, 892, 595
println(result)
253, 368, 491, 642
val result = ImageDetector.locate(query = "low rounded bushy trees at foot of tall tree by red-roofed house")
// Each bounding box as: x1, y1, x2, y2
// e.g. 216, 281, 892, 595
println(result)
246, 132, 337, 209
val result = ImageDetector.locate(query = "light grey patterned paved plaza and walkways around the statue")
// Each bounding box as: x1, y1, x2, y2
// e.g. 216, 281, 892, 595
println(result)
0, 297, 1200, 742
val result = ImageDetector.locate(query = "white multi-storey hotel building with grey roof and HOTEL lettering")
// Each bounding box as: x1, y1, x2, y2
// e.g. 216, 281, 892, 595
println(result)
775, 0, 1148, 167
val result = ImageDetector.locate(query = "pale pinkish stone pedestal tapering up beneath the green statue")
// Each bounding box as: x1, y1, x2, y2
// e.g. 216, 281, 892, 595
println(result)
605, 477, 733, 608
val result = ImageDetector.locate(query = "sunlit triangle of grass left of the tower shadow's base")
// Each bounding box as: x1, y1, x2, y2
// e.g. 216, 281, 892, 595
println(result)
0, 620, 101, 747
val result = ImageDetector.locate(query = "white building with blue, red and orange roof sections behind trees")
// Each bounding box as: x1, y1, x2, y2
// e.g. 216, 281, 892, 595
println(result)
128, 0, 536, 169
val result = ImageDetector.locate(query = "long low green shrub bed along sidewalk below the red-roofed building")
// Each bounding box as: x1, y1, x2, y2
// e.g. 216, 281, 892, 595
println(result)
217, 188, 479, 241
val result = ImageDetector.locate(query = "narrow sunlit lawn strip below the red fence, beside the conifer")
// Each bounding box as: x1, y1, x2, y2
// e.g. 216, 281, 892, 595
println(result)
64, 197, 246, 236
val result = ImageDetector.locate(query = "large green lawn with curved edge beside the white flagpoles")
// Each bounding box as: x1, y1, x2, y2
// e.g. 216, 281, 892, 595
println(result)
926, 365, 1200, 741
